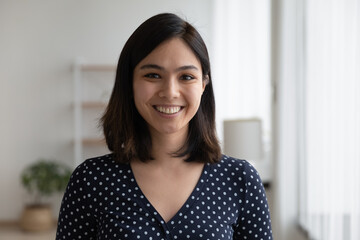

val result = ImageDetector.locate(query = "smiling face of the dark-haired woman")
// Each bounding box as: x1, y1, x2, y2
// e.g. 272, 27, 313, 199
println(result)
133, 38, 206, 139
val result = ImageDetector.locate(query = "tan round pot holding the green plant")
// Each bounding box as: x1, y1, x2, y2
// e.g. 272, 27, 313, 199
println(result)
20, 205, 54, 232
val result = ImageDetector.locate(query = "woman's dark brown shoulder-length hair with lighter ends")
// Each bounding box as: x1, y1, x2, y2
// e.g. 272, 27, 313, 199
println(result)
100, 13, 221, 163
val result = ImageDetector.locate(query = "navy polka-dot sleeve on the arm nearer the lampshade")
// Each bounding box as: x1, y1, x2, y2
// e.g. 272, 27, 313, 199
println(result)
234, 162, 273, 240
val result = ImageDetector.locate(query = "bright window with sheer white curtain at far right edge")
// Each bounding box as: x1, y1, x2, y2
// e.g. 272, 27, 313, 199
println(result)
300, 0, 360, 240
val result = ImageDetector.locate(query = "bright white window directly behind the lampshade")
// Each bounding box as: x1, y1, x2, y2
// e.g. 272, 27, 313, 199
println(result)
210, 0, 272, 182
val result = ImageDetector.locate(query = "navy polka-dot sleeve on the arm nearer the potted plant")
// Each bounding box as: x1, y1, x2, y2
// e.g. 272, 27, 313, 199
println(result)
56, 162, 96, 240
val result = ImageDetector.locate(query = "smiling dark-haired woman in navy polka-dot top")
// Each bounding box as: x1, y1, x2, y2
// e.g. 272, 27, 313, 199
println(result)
56, 14, 272, 240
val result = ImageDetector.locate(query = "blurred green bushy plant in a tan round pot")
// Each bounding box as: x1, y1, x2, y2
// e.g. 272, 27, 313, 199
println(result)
20, 159, 71, 231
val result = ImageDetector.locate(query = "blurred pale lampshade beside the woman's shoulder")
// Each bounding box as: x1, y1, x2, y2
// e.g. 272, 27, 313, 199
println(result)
224, 118, 263, 160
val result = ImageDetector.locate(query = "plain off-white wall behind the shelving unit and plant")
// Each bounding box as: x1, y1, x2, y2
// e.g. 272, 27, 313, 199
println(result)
0, 0, 212, 221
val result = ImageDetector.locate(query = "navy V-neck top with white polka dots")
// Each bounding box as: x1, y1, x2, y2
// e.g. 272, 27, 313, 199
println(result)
56, 154, 273, 240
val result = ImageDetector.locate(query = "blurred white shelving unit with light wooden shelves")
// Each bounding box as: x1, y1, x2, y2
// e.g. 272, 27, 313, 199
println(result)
73, 60, 116, 166
